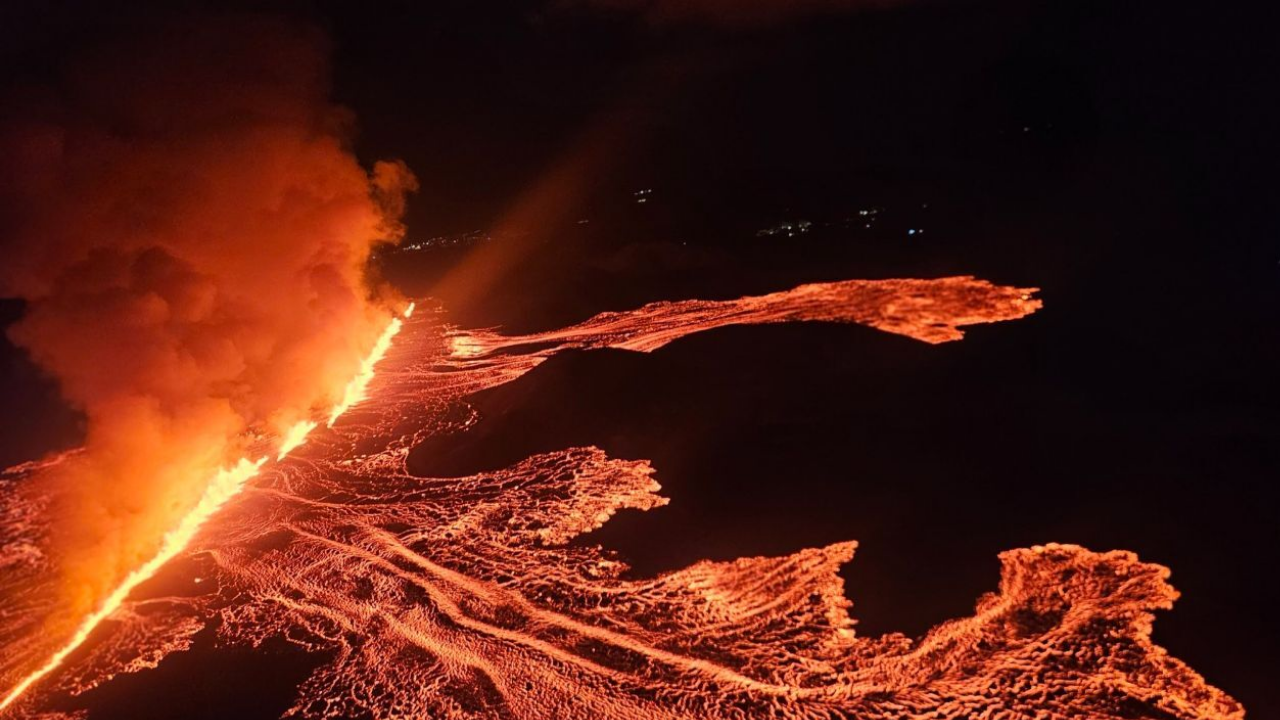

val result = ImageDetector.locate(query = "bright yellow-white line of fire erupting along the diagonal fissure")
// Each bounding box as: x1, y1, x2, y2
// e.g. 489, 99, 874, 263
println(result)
0, 304, 413, 712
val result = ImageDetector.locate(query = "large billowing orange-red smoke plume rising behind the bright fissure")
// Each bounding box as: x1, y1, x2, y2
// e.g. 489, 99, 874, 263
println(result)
0, 17, 415, 620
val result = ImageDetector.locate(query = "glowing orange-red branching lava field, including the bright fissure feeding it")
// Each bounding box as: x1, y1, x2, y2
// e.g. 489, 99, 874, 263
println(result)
0, 277, 1244, 720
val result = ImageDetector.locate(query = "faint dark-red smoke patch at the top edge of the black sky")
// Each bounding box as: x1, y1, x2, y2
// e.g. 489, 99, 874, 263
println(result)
559, 0, 896, 29
